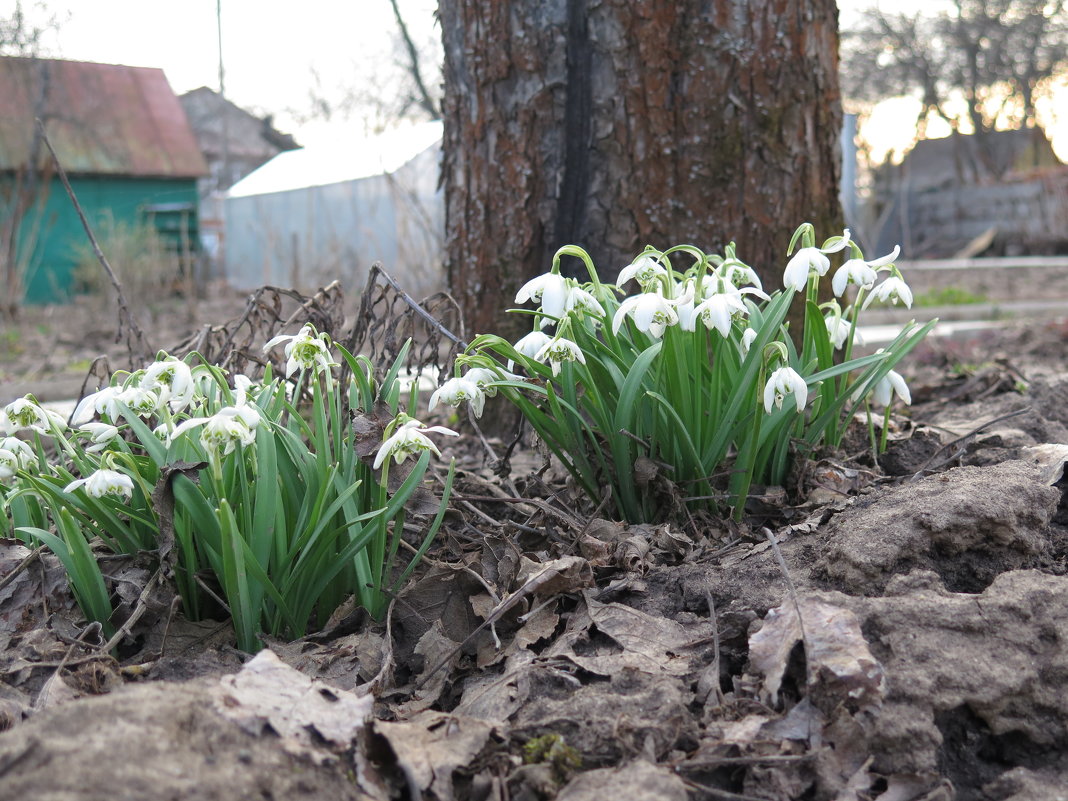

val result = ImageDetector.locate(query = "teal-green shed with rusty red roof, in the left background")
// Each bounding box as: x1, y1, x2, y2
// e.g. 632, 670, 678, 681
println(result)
0, 58, 207, 302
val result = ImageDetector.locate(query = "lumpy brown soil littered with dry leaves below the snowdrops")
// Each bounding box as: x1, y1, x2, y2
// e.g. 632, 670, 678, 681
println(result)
0, 298, 1068, 801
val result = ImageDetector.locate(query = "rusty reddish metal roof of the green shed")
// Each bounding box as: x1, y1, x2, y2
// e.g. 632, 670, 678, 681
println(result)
0, 58, 207, 177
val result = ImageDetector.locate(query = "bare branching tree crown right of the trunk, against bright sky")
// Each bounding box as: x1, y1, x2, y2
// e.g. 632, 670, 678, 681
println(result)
842, 0, 1068, 135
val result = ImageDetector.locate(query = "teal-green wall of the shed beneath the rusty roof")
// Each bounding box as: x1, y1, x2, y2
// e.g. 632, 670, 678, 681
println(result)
0, 175, 197, 303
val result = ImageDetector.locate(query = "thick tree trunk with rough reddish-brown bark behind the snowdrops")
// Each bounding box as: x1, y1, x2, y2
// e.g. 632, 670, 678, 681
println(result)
439, 0, 842, 333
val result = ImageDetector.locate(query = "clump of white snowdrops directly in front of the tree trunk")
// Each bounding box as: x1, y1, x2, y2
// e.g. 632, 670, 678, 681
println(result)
430, 223, 933, 521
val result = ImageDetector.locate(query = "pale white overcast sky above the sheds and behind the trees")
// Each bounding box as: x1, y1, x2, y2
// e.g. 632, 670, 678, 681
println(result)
0, 0, 1068, 163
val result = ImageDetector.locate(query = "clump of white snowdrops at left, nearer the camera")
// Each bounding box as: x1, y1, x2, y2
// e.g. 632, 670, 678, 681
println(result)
0, 326, 455, 651
